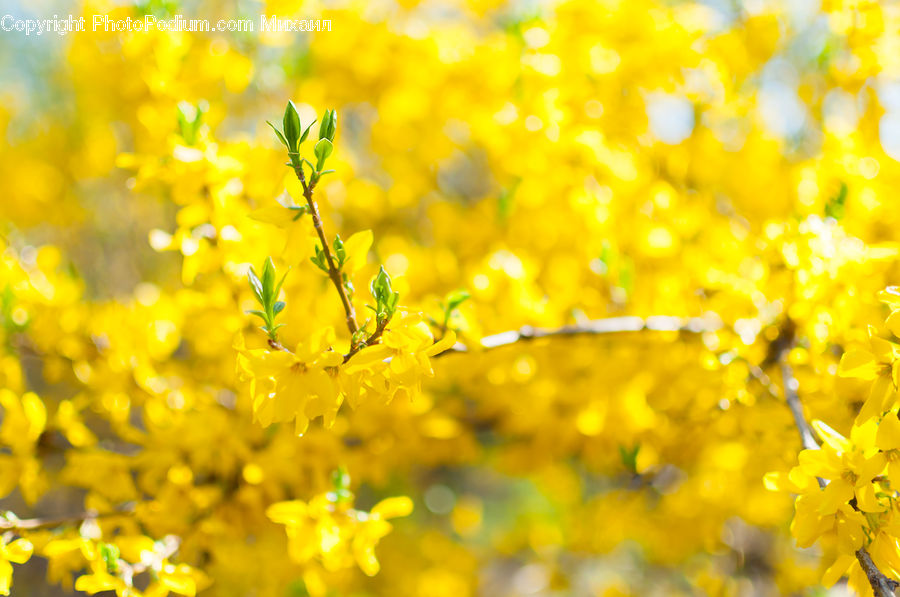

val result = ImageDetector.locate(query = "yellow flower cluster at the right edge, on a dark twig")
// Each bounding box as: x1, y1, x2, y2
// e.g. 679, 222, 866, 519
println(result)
766, 287, 900, 594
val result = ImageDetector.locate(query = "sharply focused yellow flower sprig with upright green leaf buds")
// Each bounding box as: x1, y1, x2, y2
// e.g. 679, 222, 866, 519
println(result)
235, 102, 465, 435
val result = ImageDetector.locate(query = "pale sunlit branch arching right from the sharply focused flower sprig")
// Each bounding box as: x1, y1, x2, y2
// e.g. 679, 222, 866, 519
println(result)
436, 315, 722, 356
